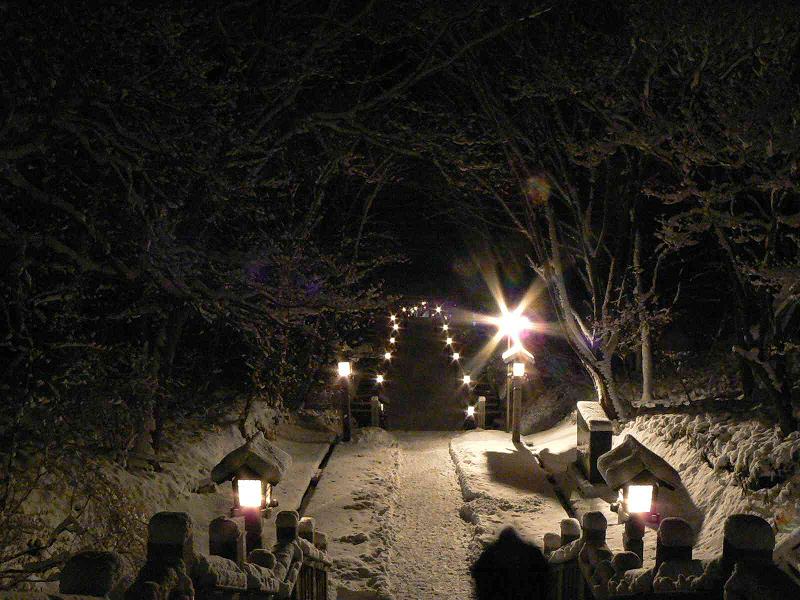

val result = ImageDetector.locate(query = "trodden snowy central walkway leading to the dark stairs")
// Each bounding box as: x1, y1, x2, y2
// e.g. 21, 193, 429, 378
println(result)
390, 432, 472, 600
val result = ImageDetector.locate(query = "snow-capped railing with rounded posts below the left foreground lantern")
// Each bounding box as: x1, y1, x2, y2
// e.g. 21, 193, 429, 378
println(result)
0, 511, 331, 600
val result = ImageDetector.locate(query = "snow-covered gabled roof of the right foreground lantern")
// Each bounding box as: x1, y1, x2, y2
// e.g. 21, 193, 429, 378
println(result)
597, 434, 681, 490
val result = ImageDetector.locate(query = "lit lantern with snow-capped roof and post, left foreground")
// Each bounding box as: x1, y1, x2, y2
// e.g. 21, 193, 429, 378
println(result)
211, 432, 292, 552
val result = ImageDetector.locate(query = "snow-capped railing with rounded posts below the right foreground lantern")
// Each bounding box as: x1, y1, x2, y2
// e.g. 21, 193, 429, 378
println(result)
545, 512, 800, 600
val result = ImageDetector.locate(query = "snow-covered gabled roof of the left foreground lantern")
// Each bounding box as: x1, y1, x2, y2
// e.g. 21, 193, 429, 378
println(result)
211, 431, 292, 485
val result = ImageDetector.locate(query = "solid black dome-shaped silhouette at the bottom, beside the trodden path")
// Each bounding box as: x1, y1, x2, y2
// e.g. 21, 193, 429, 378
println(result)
471, 527, 547, 600
